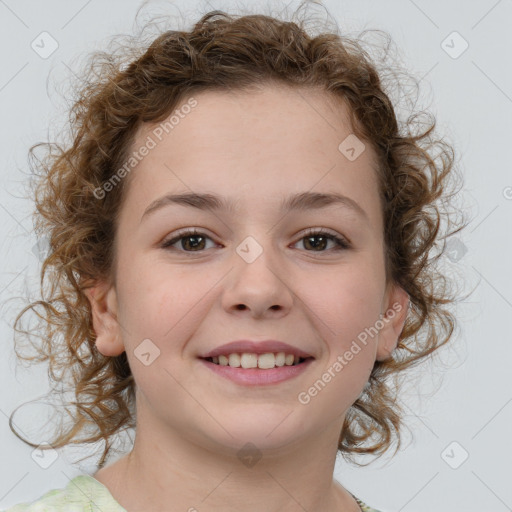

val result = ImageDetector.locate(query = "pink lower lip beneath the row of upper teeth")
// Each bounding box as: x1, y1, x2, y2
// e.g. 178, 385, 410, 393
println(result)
201, 358, 313, 386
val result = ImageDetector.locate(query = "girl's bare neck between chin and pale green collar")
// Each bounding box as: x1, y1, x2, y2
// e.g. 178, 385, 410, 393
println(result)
94, 402, 360, 512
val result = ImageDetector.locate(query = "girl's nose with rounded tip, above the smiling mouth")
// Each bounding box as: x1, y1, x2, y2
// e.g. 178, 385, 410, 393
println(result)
222, 241, 293, 318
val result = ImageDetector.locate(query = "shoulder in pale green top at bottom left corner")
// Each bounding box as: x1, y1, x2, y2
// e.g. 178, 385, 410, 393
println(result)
4, 475, 126, 512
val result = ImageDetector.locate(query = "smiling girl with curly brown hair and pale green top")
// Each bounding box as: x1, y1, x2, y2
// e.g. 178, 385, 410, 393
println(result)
6, 5, 466, 512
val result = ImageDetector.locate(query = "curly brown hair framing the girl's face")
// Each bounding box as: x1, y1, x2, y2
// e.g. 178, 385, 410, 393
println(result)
9, 4, 464, 467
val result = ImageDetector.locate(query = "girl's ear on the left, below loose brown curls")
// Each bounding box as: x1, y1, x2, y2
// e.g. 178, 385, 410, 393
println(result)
84, 281, 125, 356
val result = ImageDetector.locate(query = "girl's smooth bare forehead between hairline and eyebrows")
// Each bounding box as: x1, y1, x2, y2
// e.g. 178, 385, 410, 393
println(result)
121, 86, 378, 224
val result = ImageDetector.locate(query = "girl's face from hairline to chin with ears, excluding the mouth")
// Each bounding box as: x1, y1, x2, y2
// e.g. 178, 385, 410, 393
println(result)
90, 83, 407, 451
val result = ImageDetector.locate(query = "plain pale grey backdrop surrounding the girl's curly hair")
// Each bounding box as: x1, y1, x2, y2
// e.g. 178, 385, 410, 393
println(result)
0, 0, 512, 512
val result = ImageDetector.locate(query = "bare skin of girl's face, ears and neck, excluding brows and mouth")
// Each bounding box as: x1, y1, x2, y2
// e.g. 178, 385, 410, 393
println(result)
88, 85, 408, 512
